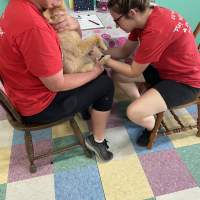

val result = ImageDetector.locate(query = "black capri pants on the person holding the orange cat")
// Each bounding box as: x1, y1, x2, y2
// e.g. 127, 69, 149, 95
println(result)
23, 71, 114, 123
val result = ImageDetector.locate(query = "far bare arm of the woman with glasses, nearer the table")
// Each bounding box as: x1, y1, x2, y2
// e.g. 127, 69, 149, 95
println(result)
104, 40, 138, 59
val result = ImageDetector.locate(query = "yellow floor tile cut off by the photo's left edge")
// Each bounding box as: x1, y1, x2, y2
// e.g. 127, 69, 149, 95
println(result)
0, 148, 11, 184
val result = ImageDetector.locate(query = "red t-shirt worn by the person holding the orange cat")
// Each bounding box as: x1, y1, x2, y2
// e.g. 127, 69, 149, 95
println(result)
0, 0, 62, 116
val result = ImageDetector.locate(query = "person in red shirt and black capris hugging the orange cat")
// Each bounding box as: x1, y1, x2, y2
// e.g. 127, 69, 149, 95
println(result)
0, 0, 114, 160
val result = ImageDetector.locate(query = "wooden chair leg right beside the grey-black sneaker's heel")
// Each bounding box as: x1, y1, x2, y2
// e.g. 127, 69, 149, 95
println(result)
70, 119, 93, 158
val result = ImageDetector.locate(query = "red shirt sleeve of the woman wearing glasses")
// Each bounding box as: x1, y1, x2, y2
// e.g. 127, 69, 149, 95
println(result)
134, 30, 170, 64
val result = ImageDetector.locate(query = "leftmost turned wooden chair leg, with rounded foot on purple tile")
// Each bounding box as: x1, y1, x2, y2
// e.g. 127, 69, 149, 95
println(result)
24, 130, 37, 173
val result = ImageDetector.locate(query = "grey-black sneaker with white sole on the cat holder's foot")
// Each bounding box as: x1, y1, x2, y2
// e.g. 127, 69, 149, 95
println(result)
85, 135, 113, 161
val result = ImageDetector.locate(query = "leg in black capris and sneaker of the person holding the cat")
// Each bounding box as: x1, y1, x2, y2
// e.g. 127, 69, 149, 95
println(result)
23, 73, 114, 160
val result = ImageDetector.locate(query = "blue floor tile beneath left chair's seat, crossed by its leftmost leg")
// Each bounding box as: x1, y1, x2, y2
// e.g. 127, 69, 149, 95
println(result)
13, 128, 52, 145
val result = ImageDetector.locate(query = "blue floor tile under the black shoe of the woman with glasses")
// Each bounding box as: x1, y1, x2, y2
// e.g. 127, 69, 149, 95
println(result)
125, 121, 174, 155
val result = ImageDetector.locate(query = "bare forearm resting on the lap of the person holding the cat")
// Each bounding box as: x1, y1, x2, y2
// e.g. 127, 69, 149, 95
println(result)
40, 66, 103, 92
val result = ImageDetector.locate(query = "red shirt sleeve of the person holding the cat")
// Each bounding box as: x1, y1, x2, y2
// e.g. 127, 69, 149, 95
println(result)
16, 28, 62, 77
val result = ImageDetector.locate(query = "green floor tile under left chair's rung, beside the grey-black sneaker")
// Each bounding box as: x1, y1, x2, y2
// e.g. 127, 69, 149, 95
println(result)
53, 136, 96, 172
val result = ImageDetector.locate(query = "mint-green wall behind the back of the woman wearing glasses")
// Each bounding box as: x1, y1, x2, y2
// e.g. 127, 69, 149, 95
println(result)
155, 0, 200, 43
